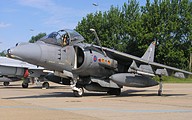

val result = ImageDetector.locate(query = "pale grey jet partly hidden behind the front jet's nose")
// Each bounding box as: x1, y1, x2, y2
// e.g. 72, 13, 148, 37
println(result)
0, 57, 49, 88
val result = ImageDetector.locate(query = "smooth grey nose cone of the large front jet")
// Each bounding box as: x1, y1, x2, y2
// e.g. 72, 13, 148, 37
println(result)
7, 43, 41, 62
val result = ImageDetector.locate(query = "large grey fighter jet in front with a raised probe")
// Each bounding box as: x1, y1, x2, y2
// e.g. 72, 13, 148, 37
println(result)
8, 29, 192, 96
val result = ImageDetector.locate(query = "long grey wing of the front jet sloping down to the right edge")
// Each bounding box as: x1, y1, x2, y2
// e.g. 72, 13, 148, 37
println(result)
99, 47, 192, 75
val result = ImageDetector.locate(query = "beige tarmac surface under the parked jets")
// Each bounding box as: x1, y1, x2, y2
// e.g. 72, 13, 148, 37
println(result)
0, 81, 192, 120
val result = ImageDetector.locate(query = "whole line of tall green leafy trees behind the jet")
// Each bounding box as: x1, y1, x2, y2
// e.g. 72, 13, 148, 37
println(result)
76, 0, 192, 70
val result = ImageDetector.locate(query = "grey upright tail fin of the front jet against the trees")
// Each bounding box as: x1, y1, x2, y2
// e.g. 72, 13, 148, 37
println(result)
141, 41, 156, 62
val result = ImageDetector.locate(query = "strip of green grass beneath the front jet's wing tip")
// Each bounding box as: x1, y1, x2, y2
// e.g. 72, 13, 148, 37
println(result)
154, 76, 192, 83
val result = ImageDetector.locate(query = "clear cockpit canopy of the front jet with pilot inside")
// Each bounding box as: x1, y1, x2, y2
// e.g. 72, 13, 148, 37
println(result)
38, 29, 84, 47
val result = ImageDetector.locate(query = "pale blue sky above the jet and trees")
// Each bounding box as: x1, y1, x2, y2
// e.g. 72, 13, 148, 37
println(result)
0, 0, 145, 52
